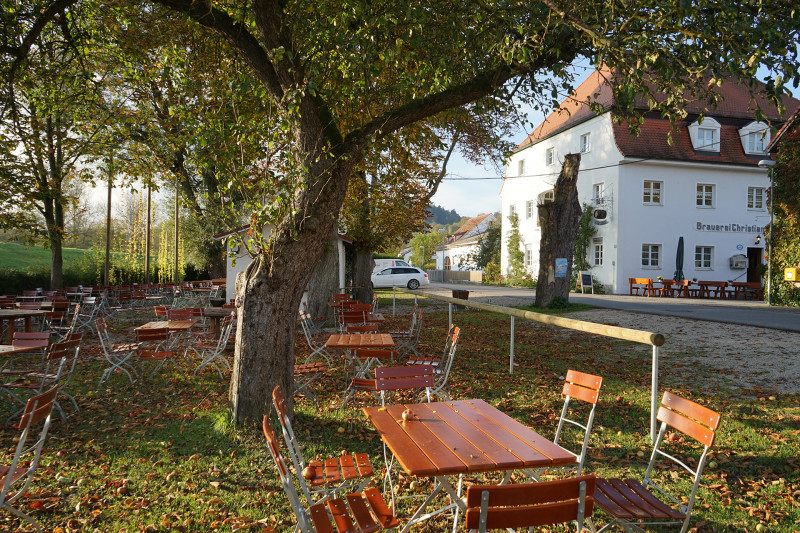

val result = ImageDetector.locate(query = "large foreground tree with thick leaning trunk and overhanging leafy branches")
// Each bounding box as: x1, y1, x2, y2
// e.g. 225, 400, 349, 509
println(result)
6, 0, 800, 423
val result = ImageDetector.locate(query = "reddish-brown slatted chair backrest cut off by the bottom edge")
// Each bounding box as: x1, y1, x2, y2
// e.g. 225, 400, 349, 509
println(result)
465, 475, 595, 533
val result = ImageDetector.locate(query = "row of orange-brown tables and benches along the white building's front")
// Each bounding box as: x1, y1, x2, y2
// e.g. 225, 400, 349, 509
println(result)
628, 278, 764, 300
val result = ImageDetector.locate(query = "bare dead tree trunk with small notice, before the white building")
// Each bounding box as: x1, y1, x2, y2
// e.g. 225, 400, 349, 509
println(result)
536, 154, 581, 307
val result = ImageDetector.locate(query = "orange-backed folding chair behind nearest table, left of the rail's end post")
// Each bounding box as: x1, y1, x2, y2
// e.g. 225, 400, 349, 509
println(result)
524, 370, 603, 481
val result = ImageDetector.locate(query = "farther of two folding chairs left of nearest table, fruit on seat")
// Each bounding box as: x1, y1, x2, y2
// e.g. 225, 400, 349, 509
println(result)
272, 386, 373, 504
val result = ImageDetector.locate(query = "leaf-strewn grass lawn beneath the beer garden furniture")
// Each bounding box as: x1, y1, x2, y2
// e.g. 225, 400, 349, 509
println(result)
0, 297, 800, 533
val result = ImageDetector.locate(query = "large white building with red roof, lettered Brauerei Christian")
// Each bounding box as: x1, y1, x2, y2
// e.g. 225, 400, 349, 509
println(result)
500, 68, 800, 293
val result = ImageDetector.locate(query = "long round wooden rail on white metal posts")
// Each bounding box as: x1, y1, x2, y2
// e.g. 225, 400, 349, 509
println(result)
392, 287, 666, 442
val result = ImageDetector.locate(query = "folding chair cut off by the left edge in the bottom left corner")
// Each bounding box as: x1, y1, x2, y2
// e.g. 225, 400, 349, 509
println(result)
0, 387, 58, 532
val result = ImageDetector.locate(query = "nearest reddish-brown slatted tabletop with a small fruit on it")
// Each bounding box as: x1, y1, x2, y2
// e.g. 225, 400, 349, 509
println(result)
364, 400, 575, 476
